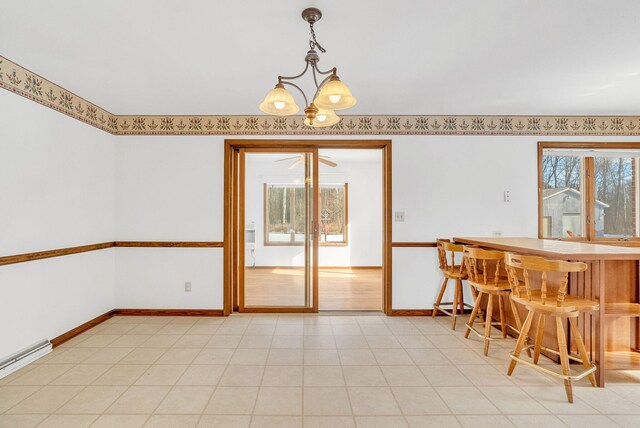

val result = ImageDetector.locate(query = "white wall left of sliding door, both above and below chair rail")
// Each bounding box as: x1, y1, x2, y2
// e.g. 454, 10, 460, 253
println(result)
115, 136, 224, 309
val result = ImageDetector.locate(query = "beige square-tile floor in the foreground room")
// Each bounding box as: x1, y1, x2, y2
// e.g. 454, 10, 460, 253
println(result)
0, 315, 640, 428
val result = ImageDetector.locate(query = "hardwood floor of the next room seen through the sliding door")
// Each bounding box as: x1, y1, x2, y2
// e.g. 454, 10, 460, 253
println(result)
245, 267, 382, 311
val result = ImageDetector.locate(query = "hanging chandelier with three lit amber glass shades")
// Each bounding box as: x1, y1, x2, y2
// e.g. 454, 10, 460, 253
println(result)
260, 7, 357, 127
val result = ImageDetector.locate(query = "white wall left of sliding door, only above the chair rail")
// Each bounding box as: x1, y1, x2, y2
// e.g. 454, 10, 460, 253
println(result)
115, 136, 224, 241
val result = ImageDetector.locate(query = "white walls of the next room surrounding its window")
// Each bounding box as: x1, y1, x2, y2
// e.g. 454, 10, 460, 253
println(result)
245, 150, 382, 266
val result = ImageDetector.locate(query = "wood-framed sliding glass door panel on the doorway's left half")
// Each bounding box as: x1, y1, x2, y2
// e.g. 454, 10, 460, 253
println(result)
238, 149, 319, 312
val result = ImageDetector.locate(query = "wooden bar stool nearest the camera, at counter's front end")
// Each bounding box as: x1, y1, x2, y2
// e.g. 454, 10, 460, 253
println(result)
505, 253, 598, 403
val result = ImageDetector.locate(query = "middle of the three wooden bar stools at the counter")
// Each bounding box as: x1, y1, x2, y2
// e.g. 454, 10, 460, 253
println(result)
463, 245, 522, 356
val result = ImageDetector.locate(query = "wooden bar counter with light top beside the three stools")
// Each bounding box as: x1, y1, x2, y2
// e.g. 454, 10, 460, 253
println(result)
454, 238, 640, 387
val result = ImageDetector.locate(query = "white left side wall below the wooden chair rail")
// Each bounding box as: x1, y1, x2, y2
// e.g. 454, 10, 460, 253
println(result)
0, 249, 115, 359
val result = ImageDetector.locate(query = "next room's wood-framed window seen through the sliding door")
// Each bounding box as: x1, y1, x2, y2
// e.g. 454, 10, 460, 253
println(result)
264, 183, 348, 245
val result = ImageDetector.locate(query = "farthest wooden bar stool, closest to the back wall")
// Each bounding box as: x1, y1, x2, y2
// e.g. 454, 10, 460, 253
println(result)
431, 239, 475, 330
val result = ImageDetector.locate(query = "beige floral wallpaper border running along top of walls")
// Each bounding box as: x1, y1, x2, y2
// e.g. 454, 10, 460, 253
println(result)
0, 56, 640, 136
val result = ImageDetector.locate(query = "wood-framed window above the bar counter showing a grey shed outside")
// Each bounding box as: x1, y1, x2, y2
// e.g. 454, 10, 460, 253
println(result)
539, 143, 640, 240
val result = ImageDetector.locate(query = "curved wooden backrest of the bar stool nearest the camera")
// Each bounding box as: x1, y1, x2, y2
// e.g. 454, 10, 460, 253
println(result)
505, 253, 587, 306
